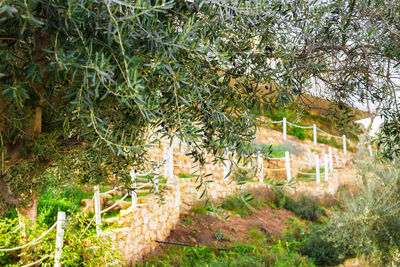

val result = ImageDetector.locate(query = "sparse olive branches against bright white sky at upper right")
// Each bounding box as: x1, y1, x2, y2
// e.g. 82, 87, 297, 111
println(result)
272, 0, 400, 151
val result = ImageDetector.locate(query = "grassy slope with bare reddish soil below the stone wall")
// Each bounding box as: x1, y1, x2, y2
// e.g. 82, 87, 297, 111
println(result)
137, 190, 340, 267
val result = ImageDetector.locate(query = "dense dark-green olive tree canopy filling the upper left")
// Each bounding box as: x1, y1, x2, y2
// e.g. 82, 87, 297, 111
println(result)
0, 0, 296, 218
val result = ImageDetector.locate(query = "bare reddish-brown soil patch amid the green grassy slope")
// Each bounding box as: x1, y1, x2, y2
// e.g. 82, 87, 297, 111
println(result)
167, 206, 295, 246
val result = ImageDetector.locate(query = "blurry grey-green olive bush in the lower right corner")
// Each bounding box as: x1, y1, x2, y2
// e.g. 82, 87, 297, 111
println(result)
322, 162, 400, 266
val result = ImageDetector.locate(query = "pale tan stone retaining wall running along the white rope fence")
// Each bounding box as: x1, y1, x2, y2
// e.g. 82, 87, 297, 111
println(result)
103, 130, 352, 266
